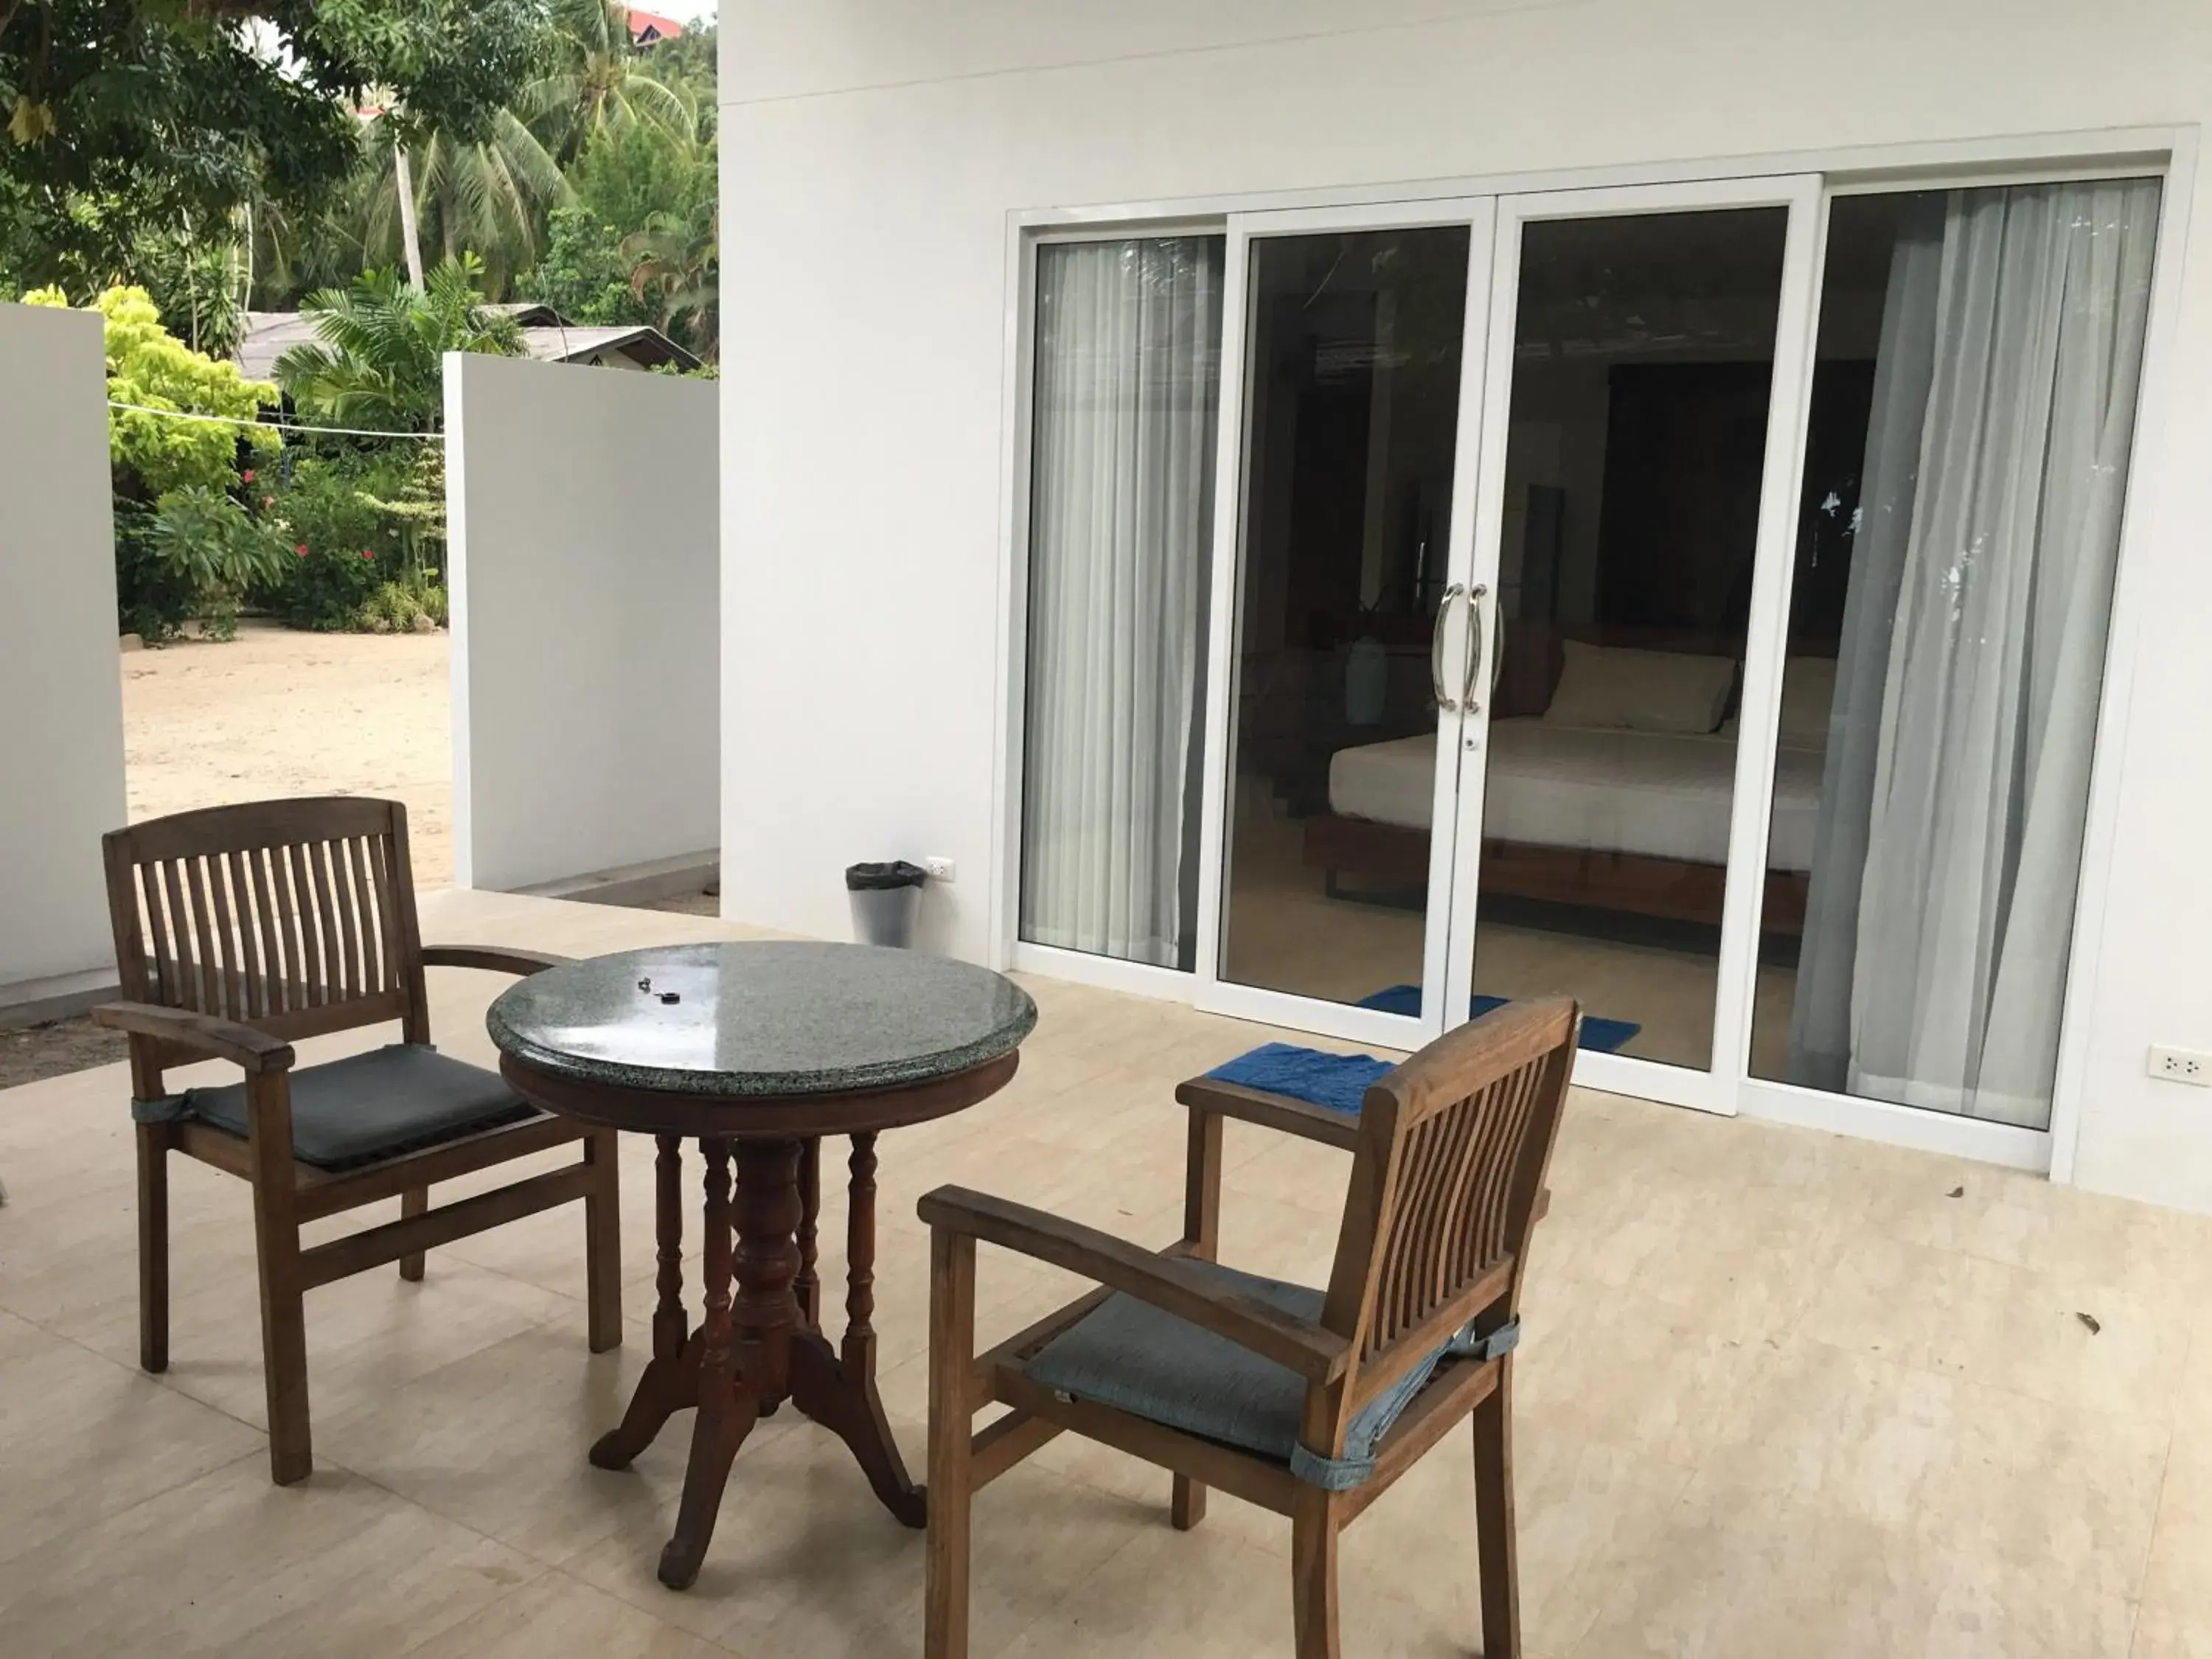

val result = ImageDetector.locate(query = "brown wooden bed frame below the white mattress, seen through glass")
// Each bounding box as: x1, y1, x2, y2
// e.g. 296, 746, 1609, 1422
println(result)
1305, 814, 1807, 938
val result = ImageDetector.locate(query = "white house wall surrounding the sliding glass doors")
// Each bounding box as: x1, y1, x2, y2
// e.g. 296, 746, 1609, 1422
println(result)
721, 0, 2212, 1210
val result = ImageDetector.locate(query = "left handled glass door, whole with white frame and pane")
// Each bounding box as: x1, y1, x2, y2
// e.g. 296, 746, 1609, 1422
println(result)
1210, 204, 1491, 1044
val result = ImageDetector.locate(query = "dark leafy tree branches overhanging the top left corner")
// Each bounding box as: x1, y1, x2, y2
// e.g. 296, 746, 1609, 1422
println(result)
0, 0, 549, 294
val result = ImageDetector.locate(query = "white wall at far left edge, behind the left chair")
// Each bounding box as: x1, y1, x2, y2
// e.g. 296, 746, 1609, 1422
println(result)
0, 305, 124, 1000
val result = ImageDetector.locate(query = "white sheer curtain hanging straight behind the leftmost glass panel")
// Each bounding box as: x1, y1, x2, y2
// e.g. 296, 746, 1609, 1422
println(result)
1022, 237, 1221, 967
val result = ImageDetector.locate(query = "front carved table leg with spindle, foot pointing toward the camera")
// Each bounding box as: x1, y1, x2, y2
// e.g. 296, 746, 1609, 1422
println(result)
661, 1139, 761, 1590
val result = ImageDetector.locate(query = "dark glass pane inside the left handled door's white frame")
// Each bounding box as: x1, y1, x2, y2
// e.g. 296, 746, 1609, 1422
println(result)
1221, 226, 1469, 1011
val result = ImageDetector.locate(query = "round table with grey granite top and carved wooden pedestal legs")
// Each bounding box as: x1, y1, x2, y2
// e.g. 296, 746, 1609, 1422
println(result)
487, 940, 1037, 1588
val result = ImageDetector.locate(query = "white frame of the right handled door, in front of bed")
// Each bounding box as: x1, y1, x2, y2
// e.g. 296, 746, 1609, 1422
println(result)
1444, 175, 1820, 1115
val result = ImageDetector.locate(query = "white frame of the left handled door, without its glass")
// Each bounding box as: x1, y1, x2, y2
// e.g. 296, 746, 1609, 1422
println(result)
1194, 197, 1498, 1048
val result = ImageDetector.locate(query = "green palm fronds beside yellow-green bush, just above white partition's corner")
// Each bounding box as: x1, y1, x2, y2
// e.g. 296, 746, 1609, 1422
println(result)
274, 257, 522, 431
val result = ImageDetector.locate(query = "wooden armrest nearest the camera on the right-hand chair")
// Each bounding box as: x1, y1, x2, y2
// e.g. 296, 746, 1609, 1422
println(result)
918, 1186, 1352, 1382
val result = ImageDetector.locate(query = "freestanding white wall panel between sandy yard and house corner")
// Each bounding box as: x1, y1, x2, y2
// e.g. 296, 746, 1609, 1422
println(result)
445, 354, 721, 891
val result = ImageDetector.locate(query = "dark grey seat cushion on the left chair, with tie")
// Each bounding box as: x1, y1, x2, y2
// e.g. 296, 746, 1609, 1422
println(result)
179, 1042, 538, 1170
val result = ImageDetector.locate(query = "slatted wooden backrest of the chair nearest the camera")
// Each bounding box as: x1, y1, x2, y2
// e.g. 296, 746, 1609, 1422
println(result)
1321, 998, 1579, 1413
